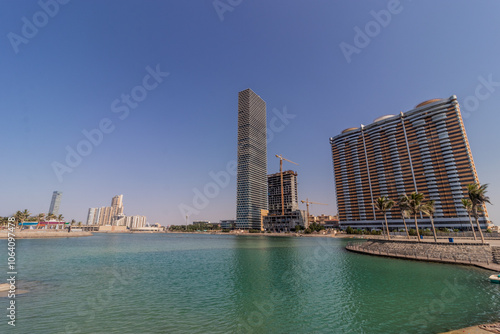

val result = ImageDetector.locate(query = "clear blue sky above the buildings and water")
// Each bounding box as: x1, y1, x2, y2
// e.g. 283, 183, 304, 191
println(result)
0, 0, 500, 225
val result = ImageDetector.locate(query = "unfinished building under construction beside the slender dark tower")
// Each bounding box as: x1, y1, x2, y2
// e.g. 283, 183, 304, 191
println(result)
264, 170, 306, 231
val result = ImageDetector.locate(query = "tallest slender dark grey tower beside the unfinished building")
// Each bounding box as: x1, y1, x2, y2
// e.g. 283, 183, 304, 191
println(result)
236, 89, 267, 229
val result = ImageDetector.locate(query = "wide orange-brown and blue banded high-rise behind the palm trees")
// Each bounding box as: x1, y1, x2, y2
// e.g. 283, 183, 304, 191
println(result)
330, 96, 487, 228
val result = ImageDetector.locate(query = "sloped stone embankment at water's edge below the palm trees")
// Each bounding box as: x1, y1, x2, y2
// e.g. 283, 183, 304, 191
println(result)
346, 239, 500, 271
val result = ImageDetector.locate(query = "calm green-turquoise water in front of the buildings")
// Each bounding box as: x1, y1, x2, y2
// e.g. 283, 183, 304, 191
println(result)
0, 234, 500, 334
